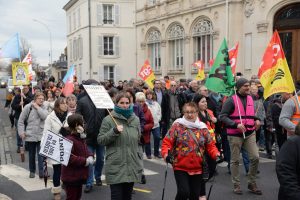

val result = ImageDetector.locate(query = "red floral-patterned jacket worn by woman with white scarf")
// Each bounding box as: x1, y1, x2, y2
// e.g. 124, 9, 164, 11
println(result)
161, 123, 219, 174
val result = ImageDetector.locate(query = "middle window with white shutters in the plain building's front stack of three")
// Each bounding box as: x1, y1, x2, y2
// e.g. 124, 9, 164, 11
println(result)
98, 36, 120, 56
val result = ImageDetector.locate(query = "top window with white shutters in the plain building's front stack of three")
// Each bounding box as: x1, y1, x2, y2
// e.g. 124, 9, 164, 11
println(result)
97, 4, 120, 25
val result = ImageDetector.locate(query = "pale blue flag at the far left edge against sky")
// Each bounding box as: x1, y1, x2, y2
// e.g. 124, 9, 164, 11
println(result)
0, 33, 21, 61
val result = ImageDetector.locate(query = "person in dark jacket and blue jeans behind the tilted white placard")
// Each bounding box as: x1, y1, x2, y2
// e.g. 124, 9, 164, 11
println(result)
76, 79, 106, 193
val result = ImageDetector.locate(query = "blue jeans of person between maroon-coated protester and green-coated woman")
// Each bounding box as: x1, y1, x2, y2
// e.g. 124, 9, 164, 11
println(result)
86, 145, 105, 186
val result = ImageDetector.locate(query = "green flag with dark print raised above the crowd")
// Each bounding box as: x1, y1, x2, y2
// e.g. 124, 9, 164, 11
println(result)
205, 38, 234, 96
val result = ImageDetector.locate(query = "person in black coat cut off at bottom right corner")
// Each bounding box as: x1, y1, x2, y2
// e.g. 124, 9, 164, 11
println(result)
276, 123, 300, 200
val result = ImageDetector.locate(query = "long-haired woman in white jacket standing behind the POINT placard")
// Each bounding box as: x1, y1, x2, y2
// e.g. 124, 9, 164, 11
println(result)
44, 97, 68, 200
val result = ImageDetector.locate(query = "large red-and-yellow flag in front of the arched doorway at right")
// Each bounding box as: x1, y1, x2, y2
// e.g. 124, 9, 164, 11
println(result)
258, 31, 295, 99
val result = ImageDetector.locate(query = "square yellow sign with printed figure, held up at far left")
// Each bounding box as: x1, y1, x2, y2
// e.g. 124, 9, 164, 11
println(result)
12, 62, 29, 86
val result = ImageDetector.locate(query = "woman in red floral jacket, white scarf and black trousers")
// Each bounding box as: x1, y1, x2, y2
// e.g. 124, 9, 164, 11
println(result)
161, 102, 220, 200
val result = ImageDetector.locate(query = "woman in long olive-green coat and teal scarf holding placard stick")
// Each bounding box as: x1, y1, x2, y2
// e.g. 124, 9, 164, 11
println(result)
97, 93, 143, 200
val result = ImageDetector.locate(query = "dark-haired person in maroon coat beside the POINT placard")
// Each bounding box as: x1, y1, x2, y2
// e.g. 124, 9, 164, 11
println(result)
61, 114, 94, 200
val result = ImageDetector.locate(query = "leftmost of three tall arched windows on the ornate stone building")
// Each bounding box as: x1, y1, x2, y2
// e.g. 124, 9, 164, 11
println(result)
147, 30, 161, 72
